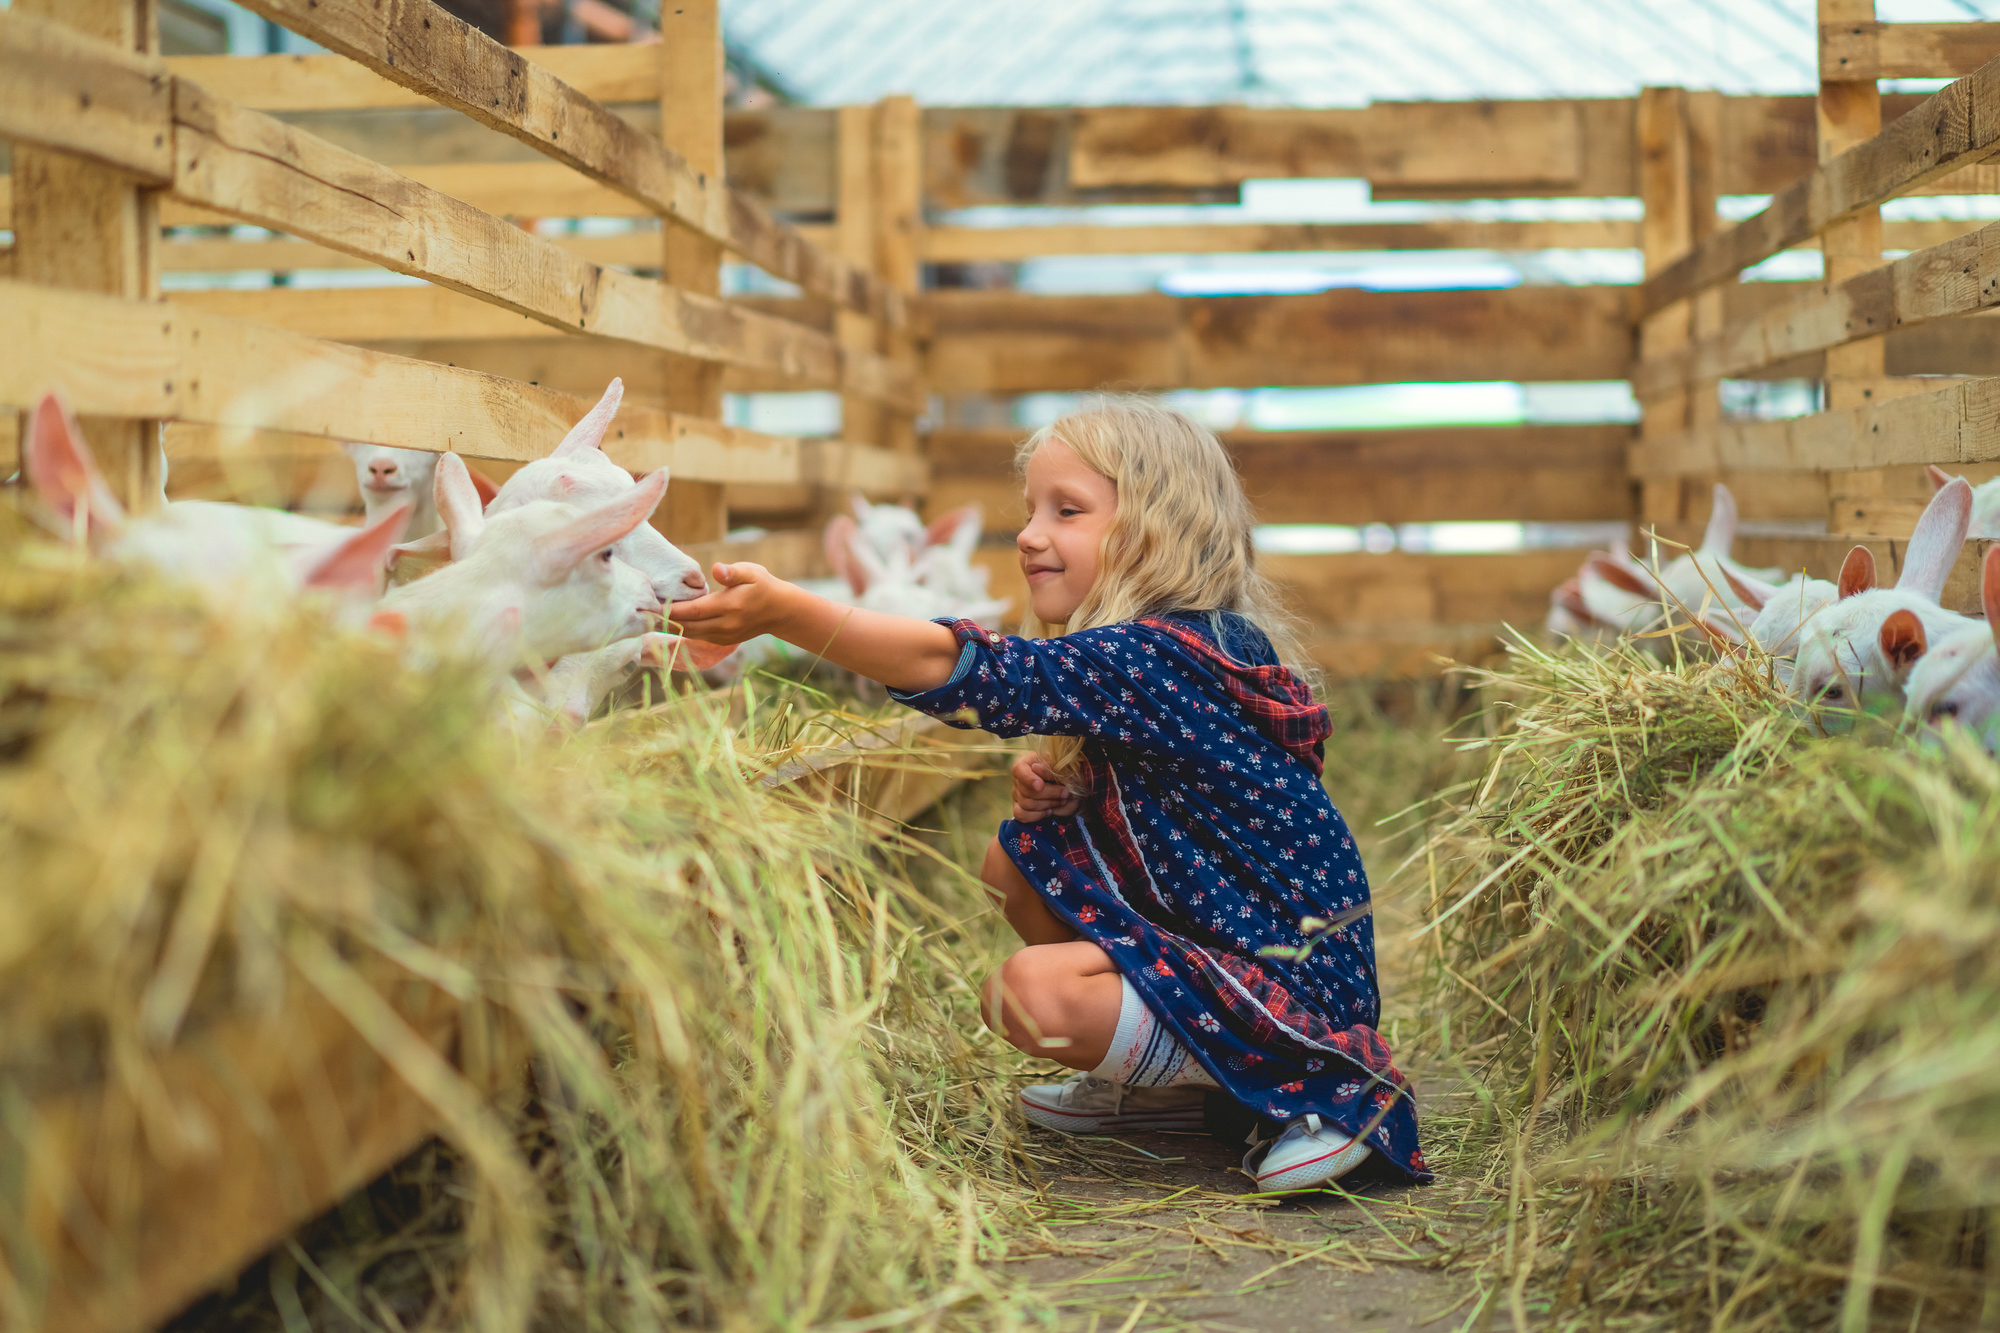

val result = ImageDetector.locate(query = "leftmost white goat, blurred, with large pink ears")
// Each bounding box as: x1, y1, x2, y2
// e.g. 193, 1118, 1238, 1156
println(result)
22, 394, 408, 600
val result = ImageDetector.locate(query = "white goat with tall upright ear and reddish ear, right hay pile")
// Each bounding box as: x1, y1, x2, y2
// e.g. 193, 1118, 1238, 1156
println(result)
1792, 478, 1972, 731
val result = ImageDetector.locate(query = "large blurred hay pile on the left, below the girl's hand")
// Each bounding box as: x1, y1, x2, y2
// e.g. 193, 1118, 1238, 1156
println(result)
0, 540, 1014, 1331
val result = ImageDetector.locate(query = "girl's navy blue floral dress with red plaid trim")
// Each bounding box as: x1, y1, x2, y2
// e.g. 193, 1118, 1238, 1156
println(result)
894, 614, 1430, 1179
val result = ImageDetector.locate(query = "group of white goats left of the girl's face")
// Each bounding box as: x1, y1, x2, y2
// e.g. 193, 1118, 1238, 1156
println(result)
22, 380, 1006, 727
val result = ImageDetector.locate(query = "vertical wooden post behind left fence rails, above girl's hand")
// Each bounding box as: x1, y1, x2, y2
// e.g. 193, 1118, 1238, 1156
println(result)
654, 0, 728, 544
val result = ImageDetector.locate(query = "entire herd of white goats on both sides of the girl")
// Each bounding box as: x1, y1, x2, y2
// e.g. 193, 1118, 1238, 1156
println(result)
22, 380, 2000, 751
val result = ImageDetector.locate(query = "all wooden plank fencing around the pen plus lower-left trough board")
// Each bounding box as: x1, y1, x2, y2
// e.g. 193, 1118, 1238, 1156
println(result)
11, 0, 2000, 1329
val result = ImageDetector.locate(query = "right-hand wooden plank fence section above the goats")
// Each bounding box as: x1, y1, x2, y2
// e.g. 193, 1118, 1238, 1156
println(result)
1630, 0, 2000, 606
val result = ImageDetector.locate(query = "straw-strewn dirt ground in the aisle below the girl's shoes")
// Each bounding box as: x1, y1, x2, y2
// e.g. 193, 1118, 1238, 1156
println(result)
1014, 1072, 1492, 1333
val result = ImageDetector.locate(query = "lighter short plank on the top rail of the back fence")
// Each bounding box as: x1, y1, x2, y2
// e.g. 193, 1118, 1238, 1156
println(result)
1070, 102, 1582, 192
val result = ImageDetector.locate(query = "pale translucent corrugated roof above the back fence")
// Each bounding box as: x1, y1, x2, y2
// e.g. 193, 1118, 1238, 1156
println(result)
722, 0, 2000, 106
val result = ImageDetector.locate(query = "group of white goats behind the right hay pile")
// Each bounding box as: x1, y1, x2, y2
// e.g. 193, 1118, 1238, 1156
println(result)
1548, 468, 2000, 751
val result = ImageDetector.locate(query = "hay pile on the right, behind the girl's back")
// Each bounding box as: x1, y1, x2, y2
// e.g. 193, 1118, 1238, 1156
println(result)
1406, 646, 2000, 1331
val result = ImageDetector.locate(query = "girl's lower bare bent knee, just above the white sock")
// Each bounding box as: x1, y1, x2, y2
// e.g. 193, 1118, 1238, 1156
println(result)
986, 939, 1124, 1069
